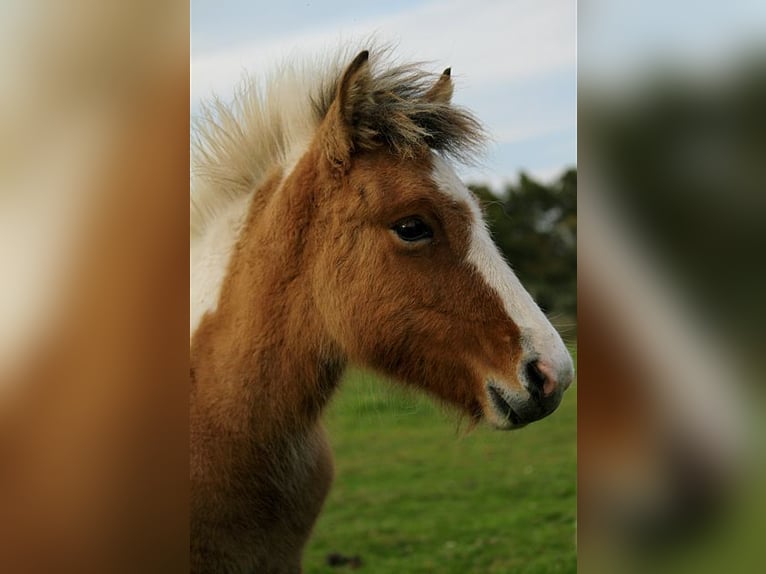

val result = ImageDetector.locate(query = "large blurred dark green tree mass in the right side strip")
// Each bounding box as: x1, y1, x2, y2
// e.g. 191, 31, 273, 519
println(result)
578, 64, 766, 363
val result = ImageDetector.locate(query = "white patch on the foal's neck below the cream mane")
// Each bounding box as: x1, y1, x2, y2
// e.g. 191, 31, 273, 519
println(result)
189, 193, 253, 337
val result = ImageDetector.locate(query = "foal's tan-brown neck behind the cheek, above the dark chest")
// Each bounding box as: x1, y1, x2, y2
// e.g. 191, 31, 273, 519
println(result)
191, 160, 346, 440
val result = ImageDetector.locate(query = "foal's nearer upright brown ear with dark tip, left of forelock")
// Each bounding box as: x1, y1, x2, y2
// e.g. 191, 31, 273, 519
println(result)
325, 50, 372, 171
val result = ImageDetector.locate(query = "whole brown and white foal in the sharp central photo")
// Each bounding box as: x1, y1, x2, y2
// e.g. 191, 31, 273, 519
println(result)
191, 51, 573, 573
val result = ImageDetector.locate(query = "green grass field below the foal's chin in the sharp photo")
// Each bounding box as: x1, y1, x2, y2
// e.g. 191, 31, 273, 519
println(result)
304, 354, 577, 574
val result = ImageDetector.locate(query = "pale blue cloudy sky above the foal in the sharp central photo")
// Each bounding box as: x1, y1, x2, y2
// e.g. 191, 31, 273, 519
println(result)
191, 0, 577, 189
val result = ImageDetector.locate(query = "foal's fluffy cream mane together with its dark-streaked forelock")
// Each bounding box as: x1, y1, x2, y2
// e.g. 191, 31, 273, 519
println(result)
190, 48, 485, 241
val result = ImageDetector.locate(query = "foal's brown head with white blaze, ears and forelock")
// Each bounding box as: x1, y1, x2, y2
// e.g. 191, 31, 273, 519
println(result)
293, 52, 573, 429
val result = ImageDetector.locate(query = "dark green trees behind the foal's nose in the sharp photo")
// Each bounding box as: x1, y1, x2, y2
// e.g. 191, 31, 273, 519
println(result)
470, 169, 577, 326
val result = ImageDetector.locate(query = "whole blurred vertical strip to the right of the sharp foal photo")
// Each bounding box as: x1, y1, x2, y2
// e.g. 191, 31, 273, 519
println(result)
578, 2, 766, 573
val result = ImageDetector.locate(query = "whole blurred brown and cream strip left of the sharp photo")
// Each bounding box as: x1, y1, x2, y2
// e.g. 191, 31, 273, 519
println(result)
0, 1, 189, 574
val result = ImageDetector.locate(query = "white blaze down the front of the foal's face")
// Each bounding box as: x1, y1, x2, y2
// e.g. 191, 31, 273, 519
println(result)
433, 155, 573, 384
